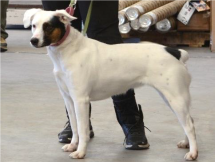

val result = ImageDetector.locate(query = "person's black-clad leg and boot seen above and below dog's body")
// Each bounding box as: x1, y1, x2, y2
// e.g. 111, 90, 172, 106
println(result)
79, 0, 149, 149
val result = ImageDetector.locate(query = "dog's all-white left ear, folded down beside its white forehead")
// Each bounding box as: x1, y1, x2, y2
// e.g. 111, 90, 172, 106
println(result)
23, 8, 42, 28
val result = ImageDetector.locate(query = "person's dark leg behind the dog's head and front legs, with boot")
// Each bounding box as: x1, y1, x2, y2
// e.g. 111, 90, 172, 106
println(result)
42, 0, 94, 143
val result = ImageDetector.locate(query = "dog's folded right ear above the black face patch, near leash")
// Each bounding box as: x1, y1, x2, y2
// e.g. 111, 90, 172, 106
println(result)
55, 10, 77, 24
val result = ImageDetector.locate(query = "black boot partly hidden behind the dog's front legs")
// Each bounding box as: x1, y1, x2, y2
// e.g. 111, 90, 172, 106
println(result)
58, 104, 94, 143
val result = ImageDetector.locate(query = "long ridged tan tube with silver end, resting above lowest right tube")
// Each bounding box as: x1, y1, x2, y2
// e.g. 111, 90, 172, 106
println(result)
139, 0, 187, 28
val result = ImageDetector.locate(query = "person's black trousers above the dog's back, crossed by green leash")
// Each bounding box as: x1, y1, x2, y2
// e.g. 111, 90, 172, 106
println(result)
79, 0, 123, 44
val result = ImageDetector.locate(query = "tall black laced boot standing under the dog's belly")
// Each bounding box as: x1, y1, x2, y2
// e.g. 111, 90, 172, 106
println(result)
112, 90, 150, 150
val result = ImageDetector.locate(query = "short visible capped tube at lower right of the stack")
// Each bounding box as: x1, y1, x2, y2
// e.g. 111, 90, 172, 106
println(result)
155, 17, 176, 33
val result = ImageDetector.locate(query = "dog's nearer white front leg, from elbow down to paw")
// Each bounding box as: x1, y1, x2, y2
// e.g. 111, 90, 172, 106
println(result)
70, 97, 90, 159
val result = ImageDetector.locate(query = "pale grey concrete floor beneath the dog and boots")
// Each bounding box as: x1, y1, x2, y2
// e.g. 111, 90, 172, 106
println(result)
0, 30, 215, 162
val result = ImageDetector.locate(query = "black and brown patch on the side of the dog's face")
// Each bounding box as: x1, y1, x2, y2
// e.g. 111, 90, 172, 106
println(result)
42, 16, 66, 46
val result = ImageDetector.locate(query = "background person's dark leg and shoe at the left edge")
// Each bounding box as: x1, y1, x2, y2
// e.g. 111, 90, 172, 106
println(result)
0, 0, 8, 52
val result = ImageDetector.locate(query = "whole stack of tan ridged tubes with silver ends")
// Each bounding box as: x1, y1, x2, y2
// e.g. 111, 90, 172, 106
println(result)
118, 0, 187, 34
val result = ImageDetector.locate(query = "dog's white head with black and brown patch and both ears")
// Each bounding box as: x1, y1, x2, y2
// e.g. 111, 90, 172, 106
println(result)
23, 9, 76, 48
